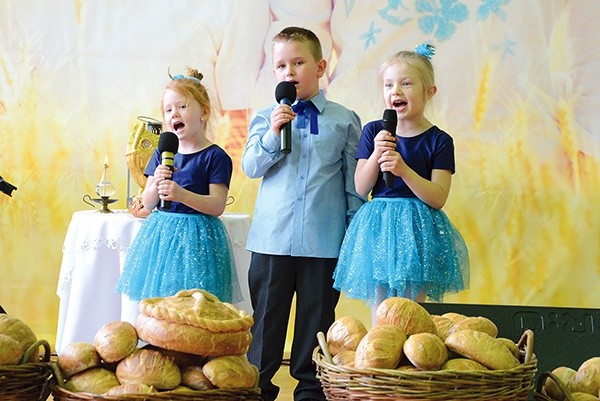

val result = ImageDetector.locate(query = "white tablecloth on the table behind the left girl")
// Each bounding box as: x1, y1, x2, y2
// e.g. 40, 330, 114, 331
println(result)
55, 210, 252, 352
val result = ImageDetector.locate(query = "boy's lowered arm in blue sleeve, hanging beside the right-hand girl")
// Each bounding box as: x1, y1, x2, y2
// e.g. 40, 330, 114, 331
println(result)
342, 112, 367, 226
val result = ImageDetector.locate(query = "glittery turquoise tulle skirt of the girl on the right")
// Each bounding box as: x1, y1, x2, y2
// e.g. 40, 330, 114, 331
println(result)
333, 198, 470, 305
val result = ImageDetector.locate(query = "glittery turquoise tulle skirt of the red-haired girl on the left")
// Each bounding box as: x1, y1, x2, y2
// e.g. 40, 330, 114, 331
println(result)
115, 211, 242, 303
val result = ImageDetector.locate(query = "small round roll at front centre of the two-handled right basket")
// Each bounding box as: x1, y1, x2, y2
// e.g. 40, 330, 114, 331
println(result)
402, 333, 448, 370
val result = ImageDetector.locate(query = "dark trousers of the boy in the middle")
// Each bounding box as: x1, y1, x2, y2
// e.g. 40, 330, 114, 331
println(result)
248, 253, 340, 401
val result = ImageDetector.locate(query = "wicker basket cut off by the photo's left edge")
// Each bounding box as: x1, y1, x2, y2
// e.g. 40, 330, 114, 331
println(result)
0, 340, 54, 401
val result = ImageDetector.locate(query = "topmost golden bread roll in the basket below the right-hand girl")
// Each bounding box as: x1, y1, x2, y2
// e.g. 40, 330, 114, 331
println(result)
375, 297, 437, 336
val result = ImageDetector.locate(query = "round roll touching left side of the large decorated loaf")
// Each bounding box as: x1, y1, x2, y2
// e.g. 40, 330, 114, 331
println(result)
94, 321, 138, 363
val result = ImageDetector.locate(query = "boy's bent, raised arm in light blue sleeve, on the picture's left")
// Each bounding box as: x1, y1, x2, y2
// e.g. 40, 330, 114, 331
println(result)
242, 113, 284, 178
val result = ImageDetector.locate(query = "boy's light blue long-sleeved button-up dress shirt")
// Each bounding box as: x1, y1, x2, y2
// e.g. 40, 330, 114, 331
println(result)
242, 92, 366, 258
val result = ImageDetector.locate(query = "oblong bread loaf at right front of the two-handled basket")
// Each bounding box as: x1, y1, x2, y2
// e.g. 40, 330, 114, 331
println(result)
445, 329, 520, 370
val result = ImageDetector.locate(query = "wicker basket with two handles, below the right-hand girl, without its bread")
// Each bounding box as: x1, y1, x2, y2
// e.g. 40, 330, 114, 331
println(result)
313, 330, 537, 401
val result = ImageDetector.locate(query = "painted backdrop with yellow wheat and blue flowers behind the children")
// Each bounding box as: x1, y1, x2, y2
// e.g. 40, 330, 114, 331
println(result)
0, 0, 600, 341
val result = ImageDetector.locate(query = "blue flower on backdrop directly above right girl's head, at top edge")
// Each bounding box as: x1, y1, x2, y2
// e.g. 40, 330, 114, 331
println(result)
415, 0, 469, 41
